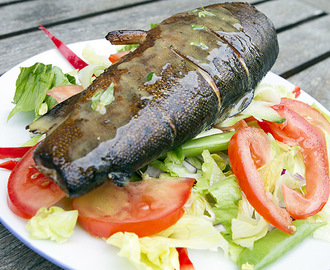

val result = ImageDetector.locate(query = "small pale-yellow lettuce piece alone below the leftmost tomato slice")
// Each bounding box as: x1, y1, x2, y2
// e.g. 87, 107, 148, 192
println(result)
26, 206, 78, 243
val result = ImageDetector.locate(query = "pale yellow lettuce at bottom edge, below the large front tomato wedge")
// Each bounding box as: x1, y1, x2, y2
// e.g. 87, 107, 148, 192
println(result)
106, 215, 228, 270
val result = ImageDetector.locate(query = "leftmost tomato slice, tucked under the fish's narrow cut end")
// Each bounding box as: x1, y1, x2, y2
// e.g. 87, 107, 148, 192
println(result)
7, 144, 65, 218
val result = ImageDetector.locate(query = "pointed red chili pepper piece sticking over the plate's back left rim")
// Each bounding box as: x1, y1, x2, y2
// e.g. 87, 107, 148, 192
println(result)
39, 24, 88, 69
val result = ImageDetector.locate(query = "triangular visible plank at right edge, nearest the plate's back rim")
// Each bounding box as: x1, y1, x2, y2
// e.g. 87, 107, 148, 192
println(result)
288, 58, 330, 110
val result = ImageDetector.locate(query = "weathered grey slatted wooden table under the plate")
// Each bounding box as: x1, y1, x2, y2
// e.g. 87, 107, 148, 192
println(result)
0, 0, 330, 269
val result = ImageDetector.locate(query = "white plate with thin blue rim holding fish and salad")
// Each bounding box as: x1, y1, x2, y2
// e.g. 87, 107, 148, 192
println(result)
0, 40, 330, 270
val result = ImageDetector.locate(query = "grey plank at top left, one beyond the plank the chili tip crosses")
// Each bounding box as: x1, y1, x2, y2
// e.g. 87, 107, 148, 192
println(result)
0, 0, 154, 36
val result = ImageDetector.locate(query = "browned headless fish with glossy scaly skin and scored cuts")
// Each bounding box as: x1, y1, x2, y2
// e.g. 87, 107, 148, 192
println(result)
28, 3, 278, 197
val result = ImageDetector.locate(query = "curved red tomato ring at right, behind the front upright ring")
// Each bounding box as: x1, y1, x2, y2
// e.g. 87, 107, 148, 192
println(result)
259, 104, 330, 219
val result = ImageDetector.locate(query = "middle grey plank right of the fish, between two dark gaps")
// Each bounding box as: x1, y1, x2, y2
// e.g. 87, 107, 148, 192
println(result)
272, 15, 330, 74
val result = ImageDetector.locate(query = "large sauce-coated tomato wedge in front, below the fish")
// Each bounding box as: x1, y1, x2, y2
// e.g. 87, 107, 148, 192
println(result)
72, 178, 195, 238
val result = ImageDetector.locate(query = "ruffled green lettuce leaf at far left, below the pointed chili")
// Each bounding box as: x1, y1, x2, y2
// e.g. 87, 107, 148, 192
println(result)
7, 63, 75, 121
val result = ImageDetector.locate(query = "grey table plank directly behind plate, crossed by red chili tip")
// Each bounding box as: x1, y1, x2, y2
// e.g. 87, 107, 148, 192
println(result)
0, 0, 256, 74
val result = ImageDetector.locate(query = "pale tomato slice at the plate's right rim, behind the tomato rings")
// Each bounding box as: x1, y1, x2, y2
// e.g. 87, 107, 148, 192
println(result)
281, 98, 330, 136
